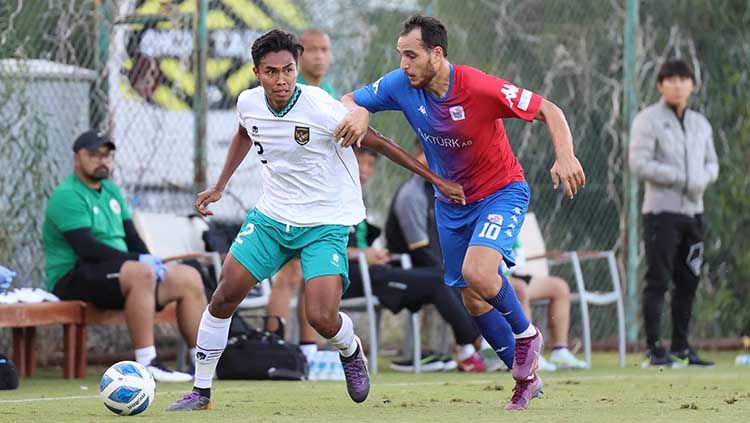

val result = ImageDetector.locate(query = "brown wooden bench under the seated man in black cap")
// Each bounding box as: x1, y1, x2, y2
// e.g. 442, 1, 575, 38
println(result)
0, 301, 177, 379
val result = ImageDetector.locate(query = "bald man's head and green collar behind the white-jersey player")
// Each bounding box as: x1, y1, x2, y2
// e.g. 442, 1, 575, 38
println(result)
297, 29, 338, 99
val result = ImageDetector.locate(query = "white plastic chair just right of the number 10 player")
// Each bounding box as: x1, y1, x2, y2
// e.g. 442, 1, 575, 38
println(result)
514, 213, 625, 368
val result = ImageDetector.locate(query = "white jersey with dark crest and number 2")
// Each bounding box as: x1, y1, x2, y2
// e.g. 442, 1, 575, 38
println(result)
237, 84, 365, 226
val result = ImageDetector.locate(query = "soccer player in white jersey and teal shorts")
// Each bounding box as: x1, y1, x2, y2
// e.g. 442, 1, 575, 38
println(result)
168, 30, 465, 411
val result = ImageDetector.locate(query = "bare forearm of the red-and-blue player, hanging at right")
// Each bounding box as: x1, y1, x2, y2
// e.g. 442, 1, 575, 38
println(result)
535, 99, 586, 198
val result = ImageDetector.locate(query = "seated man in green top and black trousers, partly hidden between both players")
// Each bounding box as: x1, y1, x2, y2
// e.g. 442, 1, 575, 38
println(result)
344, 148, 485, 372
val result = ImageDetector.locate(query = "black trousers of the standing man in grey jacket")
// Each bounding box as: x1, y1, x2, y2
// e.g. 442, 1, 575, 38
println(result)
642, 213, 703, 351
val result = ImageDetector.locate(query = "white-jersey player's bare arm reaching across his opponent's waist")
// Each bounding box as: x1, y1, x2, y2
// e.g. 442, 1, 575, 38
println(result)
362, 128, 466, 205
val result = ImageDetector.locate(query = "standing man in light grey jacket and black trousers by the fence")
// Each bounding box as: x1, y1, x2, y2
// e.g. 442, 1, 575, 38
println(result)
630, 60, 719, 366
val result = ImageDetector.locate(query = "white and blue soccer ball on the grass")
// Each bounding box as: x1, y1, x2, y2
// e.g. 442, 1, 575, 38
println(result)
99, 361, 156, 416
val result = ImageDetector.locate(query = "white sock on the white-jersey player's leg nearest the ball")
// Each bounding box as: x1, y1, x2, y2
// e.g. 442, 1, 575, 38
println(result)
194, 307, 232, 389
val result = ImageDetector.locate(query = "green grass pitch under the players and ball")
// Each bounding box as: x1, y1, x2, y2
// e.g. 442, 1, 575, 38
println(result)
0, 353, 750, 423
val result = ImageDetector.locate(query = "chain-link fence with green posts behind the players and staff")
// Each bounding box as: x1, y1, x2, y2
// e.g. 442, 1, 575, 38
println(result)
0, 0, 750, 358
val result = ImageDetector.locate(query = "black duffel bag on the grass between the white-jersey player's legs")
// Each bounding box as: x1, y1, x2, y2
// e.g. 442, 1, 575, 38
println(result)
216, 324, 307, 380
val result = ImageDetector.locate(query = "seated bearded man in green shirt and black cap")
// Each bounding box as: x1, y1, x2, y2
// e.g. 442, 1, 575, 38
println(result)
42, 131, 206, 382
